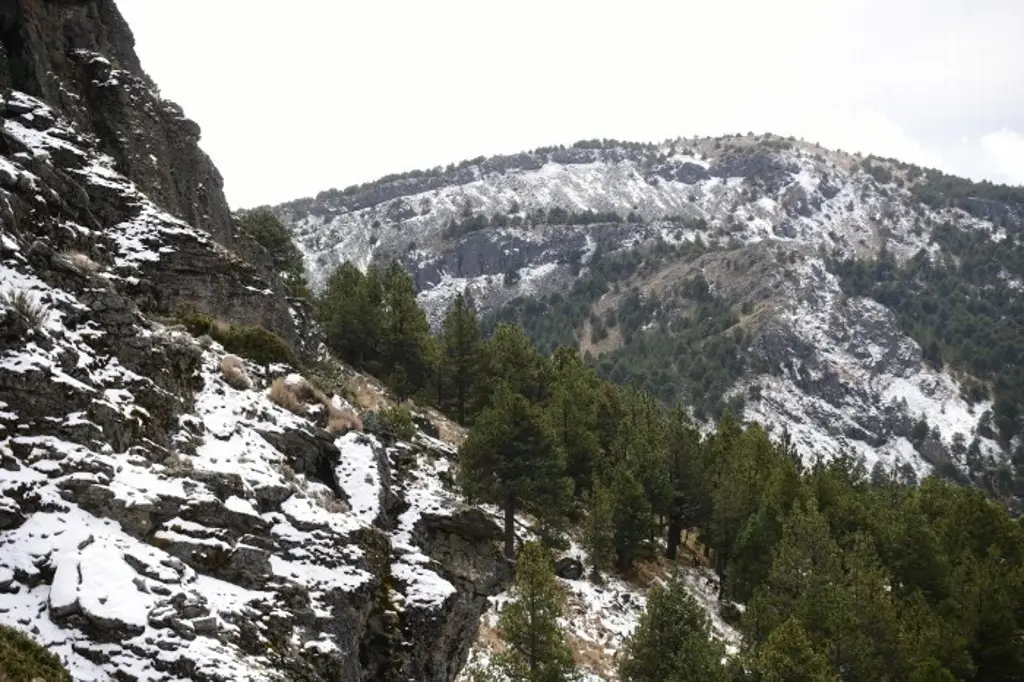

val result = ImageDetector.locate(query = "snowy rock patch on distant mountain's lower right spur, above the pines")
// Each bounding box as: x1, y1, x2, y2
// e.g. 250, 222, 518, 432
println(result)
735, 258, 991, 475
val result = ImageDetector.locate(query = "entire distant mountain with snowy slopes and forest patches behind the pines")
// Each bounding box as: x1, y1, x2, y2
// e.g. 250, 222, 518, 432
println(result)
273, 135, 1024, 496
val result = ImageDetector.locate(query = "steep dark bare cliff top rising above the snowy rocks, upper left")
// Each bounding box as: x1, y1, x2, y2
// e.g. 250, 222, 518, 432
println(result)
0, 0, 232, 246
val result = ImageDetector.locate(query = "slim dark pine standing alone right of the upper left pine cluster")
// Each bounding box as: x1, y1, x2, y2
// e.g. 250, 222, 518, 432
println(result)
438, 294, 482, 424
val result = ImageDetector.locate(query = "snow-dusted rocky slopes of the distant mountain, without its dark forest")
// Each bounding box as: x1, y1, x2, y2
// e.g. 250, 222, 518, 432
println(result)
274, 135, 1024, 476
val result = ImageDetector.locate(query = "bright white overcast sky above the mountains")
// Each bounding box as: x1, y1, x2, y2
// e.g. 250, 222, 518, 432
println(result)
117, 0, 1024, 208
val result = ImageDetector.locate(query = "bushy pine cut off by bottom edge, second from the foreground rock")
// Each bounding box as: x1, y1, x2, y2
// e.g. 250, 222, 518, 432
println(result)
618, 581, 728, 682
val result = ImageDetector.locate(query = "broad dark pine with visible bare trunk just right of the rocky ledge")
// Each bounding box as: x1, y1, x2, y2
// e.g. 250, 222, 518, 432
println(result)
459, 384, 572, 559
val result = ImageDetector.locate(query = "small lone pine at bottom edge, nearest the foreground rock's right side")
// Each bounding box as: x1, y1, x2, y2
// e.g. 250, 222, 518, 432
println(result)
495, 543, 577, 682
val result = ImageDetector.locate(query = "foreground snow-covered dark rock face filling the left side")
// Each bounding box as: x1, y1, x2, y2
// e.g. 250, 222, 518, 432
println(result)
0, 5, 508, 682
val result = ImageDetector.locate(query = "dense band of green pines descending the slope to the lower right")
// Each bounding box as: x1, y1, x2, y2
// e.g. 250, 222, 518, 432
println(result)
318, 256, 1024, 682
